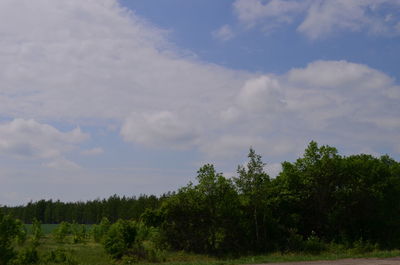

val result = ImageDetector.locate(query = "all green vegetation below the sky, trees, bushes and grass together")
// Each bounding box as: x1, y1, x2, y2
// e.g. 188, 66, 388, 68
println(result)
0, 142, 400, 265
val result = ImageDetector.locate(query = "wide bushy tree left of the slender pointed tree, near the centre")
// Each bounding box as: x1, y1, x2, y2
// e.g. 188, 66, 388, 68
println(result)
161, 164, 241, 254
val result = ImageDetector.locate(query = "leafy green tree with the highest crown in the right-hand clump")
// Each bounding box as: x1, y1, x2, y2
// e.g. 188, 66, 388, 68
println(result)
276, 141, 342, 238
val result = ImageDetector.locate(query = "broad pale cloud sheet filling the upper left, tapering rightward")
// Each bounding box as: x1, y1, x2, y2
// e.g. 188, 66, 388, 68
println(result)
0, 0, 247, 122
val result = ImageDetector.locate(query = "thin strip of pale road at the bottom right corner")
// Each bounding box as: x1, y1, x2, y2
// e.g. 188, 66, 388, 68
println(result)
253, 257, 400, 265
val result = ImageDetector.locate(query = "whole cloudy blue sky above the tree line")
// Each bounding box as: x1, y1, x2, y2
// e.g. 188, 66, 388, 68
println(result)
0, 0, 400, 205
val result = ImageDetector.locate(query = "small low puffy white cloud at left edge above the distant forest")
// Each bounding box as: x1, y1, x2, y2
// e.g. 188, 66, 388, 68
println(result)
0, 119, 89, 159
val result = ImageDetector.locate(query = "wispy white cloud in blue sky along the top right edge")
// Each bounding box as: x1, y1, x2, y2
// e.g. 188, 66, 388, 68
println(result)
233, 0, 400, 39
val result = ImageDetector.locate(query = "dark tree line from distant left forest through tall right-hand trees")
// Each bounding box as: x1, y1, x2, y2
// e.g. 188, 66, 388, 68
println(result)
2, 142, 400, 254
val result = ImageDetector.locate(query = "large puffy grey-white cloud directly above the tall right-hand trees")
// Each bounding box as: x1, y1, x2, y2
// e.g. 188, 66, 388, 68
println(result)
214, 61, 400, 157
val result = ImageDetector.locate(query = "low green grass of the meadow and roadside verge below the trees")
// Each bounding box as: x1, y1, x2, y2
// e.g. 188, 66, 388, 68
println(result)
18, 225, 400, 265
